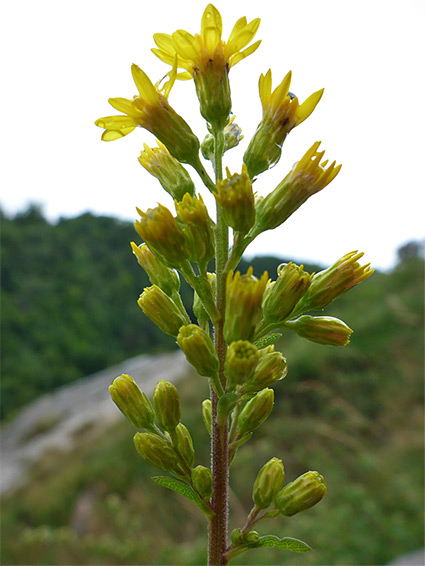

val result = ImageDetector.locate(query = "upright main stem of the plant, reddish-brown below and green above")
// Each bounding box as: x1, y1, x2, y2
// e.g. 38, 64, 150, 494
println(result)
208, 131, 229, 566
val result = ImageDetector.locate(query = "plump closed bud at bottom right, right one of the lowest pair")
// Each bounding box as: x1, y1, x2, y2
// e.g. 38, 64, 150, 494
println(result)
275, 472, 327, 517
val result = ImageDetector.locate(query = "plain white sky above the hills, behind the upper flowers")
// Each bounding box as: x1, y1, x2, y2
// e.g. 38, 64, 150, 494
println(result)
0, 0, 425, 268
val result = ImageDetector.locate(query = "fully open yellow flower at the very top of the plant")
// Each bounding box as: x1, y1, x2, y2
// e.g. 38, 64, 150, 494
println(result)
152, 4, 261, 129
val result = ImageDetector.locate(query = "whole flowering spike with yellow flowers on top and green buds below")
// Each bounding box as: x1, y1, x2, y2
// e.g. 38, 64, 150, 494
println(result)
96, 4, 373, 564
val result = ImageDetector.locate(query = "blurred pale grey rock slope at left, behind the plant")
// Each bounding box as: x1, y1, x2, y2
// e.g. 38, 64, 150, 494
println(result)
0, 351, 193, 500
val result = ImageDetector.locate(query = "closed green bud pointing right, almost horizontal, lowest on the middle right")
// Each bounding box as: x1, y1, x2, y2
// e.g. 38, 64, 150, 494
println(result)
285, 315, 353, 346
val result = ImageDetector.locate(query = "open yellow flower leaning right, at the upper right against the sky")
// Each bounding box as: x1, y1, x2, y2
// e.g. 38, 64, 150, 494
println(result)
244, 69, 324, 178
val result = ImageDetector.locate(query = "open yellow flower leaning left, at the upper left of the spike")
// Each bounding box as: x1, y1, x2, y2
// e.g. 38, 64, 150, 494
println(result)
95, 62, 199, 164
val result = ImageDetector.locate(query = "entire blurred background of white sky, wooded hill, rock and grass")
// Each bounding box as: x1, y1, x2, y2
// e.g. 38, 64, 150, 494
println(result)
0, 0, 425, 566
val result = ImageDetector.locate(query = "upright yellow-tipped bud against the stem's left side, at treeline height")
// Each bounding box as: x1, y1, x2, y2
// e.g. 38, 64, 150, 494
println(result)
175, 194, 214, 263
